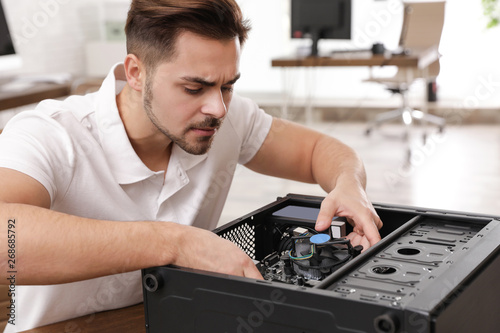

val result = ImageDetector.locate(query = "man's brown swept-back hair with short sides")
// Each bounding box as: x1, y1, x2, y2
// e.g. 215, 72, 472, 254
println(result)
125, 0, 250, 70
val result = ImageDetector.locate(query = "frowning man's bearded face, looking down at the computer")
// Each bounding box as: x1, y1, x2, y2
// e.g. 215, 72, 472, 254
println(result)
144, 32, 240, 155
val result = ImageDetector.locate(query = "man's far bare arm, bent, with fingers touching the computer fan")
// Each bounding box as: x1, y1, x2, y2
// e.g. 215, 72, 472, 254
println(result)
246, 118, 382, 248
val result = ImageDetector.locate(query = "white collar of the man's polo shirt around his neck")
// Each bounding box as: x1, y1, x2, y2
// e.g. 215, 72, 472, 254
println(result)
95, 63, 207, 184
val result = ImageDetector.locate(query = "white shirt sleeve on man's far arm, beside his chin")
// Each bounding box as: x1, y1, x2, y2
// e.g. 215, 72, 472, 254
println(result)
228, 94, 273, 164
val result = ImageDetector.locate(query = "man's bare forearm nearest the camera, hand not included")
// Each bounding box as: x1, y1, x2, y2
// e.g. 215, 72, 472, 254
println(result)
0, 203, 180, 284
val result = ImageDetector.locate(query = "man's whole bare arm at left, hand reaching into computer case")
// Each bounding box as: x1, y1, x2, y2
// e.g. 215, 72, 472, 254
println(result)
0, 168, 261, 285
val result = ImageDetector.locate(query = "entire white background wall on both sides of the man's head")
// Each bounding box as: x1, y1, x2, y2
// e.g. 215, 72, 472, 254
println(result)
3, 0, 500, 104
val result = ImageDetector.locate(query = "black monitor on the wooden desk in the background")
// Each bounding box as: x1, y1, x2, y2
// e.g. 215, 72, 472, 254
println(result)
291, 0, 351, 56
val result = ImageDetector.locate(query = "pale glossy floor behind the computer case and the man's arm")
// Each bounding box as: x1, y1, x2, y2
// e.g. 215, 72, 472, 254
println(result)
219, 122, 500, 224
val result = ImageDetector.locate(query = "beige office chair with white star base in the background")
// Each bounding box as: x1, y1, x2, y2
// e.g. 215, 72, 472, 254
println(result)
365, 1, 445, 144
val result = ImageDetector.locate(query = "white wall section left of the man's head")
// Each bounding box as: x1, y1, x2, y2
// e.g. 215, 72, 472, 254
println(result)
2, 0, 128, 75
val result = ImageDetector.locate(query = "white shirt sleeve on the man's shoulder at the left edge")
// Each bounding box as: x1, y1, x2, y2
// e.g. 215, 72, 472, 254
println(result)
0, 111, 74, 202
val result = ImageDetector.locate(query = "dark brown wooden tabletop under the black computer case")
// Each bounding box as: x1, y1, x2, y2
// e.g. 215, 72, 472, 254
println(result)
24, 303, 146, 333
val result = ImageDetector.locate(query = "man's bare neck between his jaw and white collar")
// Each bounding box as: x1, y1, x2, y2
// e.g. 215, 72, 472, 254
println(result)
116, 84, 172, 171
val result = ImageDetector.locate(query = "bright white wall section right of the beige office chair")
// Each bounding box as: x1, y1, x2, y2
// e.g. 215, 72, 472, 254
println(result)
438, 0, 500, 106
